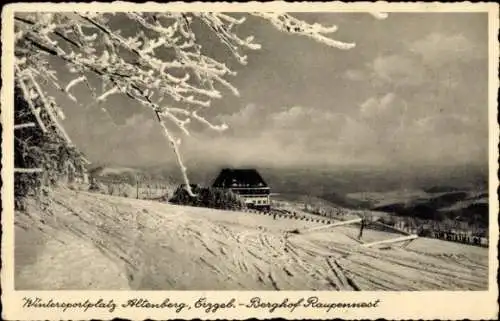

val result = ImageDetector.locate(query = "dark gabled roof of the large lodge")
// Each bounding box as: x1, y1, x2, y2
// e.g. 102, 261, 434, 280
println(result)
212, 168, 268, 188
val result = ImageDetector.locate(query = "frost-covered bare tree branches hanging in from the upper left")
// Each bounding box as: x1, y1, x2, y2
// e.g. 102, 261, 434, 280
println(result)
15, 12, 385, 195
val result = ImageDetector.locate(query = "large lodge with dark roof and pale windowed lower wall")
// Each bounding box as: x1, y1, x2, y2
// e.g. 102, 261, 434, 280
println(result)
212, 168, 271, 210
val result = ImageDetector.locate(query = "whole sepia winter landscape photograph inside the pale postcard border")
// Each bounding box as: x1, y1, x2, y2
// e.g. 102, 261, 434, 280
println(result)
13, 11, 488, 291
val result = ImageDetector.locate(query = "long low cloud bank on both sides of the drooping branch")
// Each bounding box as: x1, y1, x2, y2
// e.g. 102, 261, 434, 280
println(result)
76, 92, 487, 168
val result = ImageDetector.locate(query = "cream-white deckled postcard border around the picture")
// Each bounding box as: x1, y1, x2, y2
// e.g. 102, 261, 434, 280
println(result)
1, 2, 499, 320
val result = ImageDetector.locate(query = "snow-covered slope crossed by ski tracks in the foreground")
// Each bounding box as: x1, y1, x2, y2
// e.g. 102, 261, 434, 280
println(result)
15, 189, 488, 291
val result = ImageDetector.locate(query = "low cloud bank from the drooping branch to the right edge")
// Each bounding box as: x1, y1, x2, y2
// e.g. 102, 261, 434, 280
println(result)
178, 92, 486, 168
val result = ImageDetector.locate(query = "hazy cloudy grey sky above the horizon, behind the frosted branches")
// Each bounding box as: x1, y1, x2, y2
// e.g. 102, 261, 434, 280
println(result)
51, 13, 488, 172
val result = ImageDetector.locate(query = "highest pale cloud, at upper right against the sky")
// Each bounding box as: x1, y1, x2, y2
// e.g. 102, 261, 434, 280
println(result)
343, 32, 488, 89
